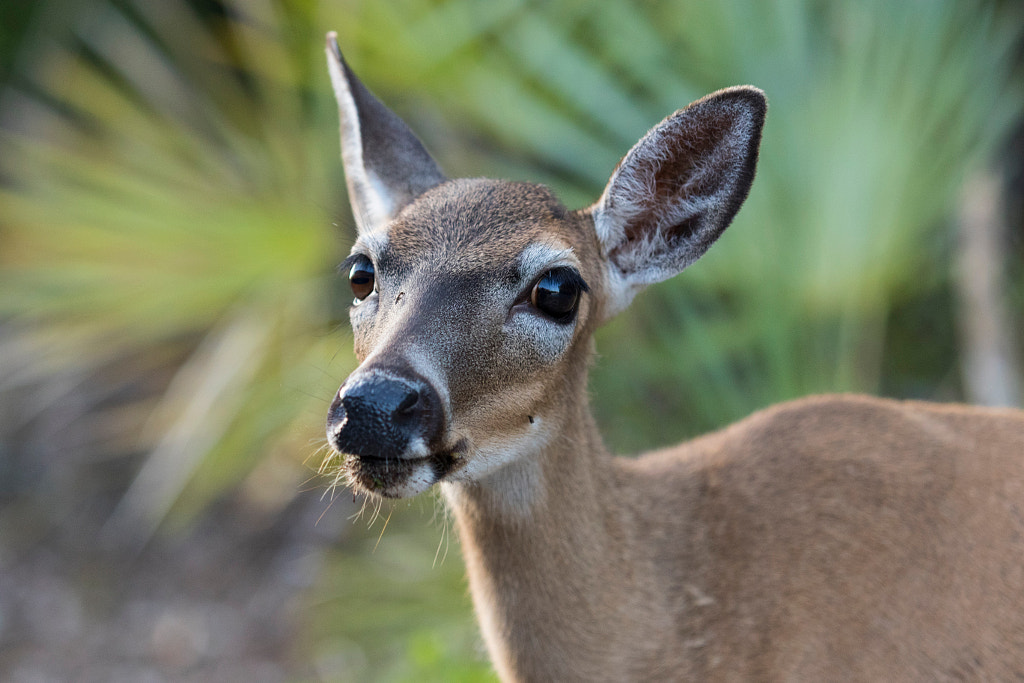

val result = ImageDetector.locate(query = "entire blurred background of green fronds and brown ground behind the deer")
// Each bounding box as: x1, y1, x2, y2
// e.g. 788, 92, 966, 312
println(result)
0, 0, 1024, 682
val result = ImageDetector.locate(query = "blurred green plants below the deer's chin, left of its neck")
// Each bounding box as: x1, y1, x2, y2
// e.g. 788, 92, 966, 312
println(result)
298, 501, 495, 683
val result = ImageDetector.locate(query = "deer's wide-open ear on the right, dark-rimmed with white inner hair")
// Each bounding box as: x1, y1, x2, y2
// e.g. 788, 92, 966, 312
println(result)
588, 87, 767, 317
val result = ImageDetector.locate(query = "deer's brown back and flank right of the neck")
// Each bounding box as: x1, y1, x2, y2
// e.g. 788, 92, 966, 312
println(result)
618, 396, 1024, 680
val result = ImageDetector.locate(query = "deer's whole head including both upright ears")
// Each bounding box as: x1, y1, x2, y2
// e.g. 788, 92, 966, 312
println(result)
327, 34, 766, 497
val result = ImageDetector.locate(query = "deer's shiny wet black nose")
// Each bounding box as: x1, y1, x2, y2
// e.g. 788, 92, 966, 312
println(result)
327, 374, 441, 458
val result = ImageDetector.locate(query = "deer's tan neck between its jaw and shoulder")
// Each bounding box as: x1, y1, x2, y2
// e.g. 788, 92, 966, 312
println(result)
445, 397, 675, 680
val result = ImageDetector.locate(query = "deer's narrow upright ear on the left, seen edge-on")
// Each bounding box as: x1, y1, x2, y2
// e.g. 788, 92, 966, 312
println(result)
327, 32, 445, 234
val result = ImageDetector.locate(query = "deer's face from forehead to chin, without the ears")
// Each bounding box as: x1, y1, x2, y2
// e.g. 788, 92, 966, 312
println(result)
328, 180, 602, 497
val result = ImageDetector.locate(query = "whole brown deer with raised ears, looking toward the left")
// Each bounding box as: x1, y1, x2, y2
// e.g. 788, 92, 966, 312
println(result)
327, 33, 1024, 681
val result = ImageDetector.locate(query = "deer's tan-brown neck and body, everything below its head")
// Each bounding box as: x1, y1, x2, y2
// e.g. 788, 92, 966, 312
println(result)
454, 396, 1024, 681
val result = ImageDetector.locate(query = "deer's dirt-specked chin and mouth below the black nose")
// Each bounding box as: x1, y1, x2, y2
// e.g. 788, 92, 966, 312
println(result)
345, 449, 466, 498
